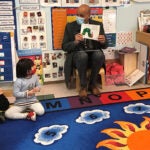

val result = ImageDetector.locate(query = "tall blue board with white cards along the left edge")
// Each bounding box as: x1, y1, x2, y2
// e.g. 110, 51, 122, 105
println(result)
0, 0, 18, 82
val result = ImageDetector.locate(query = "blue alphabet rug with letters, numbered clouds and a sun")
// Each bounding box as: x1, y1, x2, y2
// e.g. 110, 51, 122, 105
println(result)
0, 88, 150, 150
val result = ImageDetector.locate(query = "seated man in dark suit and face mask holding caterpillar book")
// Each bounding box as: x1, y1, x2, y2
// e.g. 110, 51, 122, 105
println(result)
62, 4, 107, 98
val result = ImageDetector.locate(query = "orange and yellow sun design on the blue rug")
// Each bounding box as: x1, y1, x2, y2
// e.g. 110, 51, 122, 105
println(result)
96, 117, 150, 150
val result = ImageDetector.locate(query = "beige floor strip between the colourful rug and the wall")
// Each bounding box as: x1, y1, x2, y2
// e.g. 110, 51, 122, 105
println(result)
0, 82, 150, 103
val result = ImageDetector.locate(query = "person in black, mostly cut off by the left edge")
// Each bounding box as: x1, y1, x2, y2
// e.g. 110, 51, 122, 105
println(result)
0, 88, 9, 123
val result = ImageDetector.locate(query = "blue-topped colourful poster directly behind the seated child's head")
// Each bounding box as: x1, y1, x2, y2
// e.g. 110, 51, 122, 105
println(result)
17, 49, 43, 84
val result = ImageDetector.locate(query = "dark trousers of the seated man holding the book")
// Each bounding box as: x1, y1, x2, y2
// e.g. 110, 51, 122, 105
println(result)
73, 50, 105, 88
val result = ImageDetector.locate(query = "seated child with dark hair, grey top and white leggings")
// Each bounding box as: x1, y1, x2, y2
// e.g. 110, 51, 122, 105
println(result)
5, 58, 44, 121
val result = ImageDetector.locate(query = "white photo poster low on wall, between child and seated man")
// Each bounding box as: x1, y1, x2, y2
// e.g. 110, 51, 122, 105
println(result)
42, 51, 65, 82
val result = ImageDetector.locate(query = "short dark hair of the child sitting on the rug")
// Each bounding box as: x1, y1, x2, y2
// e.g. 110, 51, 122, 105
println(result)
16, 58, 34, 78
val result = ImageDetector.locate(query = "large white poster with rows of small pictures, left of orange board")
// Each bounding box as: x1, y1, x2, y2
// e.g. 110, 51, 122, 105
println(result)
19, 10, 47, 50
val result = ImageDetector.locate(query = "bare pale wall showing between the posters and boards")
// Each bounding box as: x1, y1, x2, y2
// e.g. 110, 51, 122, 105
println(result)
15, 0, 150, 50
